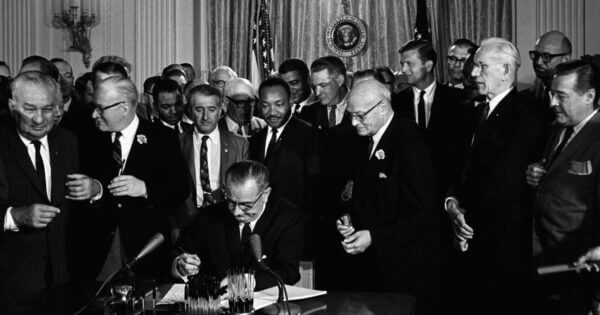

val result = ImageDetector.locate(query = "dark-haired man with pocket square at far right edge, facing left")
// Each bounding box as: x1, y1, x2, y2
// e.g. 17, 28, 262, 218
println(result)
527, 60, 600, 315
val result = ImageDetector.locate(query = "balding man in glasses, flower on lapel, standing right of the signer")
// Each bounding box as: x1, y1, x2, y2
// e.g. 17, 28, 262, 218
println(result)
337, 80, 438, 314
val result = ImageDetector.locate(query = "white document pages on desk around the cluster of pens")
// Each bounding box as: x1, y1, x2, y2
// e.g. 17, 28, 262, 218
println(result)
157, 283, 327, 310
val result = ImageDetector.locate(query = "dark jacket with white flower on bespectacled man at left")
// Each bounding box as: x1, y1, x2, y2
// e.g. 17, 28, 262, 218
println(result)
74, 119, 190, 278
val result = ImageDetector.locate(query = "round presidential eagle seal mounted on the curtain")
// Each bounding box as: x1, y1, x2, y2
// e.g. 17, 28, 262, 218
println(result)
325, 15, 367, 57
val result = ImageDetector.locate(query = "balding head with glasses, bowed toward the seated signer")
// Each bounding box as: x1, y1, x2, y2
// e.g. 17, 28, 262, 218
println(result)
346, 80, 394, 136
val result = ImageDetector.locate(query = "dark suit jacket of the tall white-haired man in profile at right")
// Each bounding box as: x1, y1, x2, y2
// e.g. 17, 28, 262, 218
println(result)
452, 89, 541, 288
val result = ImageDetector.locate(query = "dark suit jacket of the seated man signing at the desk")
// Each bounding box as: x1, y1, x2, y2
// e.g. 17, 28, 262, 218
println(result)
178, 198, 304, 290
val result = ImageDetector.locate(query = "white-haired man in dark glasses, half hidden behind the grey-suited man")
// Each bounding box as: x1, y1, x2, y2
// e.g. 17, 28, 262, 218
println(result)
220, 78, 267, 138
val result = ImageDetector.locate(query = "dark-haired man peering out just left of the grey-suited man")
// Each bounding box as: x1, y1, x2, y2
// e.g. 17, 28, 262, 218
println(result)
152, 79, 193, 133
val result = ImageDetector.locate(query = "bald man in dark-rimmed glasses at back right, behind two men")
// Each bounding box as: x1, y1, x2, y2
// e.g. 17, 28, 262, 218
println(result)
519, 31, 571, 139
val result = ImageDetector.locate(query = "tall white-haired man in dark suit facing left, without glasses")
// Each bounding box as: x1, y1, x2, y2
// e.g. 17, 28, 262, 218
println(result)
445, 38, 541, 314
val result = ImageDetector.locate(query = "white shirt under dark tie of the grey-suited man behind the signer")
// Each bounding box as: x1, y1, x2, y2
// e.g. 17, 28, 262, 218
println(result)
193, 127, 221, 207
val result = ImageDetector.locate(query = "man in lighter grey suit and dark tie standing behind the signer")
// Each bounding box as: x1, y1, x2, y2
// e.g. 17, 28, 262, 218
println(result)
176, 84, 248, 232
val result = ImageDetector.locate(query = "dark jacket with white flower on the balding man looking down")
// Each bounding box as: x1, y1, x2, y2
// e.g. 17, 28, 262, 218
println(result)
350, 115, 438, 296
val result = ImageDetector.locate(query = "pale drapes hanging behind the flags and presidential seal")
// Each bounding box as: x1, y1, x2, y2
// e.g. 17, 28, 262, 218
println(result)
208, 0, 512, 81
